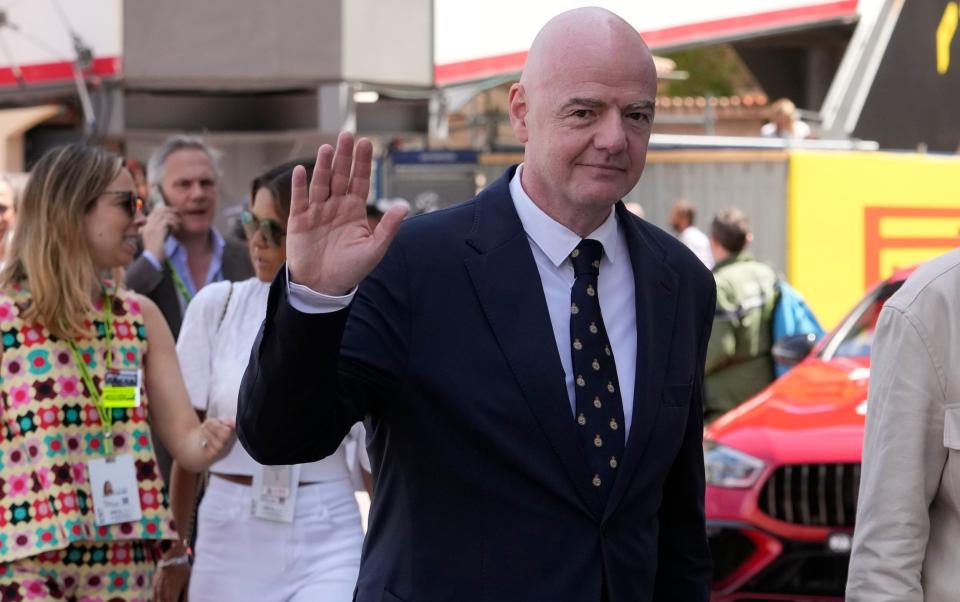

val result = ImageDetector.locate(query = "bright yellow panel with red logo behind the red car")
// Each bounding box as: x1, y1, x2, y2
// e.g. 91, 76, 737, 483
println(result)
787, 151, 960, 327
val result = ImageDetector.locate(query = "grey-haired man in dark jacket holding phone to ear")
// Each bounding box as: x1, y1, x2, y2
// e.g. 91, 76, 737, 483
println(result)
126, 135, 253, 482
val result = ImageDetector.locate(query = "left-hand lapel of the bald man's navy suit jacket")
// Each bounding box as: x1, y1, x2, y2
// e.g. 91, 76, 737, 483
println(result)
465, 169, 603, 517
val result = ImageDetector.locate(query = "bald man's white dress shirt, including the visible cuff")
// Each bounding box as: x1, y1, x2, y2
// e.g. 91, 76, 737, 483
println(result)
287, 164, 637, 437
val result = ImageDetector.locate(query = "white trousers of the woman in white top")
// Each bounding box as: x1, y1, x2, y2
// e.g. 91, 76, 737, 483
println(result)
190, 476, 363, 602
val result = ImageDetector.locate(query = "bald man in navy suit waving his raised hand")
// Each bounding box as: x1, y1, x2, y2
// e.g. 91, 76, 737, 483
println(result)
238, 8, 716, 602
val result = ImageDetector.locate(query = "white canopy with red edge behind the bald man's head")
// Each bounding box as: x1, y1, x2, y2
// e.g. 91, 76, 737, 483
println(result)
434, 0, 867, 86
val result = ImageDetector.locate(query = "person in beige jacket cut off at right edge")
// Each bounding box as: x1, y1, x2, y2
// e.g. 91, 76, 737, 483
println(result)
847, 249, 960, 602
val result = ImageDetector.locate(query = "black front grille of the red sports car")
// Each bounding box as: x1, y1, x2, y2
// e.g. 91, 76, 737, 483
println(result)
757, 464, 860, 528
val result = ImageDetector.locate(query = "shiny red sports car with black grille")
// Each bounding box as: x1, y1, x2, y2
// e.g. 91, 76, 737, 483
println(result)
704, 270, 910, 602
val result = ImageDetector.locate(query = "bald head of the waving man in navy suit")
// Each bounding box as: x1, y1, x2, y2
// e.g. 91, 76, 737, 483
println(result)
510, 8, 657, 236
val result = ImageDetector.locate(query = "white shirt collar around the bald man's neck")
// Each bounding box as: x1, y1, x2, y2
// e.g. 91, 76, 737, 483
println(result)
510, 163, 620, 267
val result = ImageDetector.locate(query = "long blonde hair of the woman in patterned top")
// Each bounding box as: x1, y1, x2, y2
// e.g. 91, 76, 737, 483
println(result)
0, 144, 123, 339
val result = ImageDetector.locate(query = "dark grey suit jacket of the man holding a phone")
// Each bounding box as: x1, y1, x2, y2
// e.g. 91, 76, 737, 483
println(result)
126, 234, 253, 339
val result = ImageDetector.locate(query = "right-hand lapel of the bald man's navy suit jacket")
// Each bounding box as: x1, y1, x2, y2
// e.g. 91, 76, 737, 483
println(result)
604, 203, 679, 516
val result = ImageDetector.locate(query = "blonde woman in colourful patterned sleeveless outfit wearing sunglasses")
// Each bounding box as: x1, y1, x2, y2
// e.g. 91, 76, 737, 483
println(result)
0, 144, 233, 600
